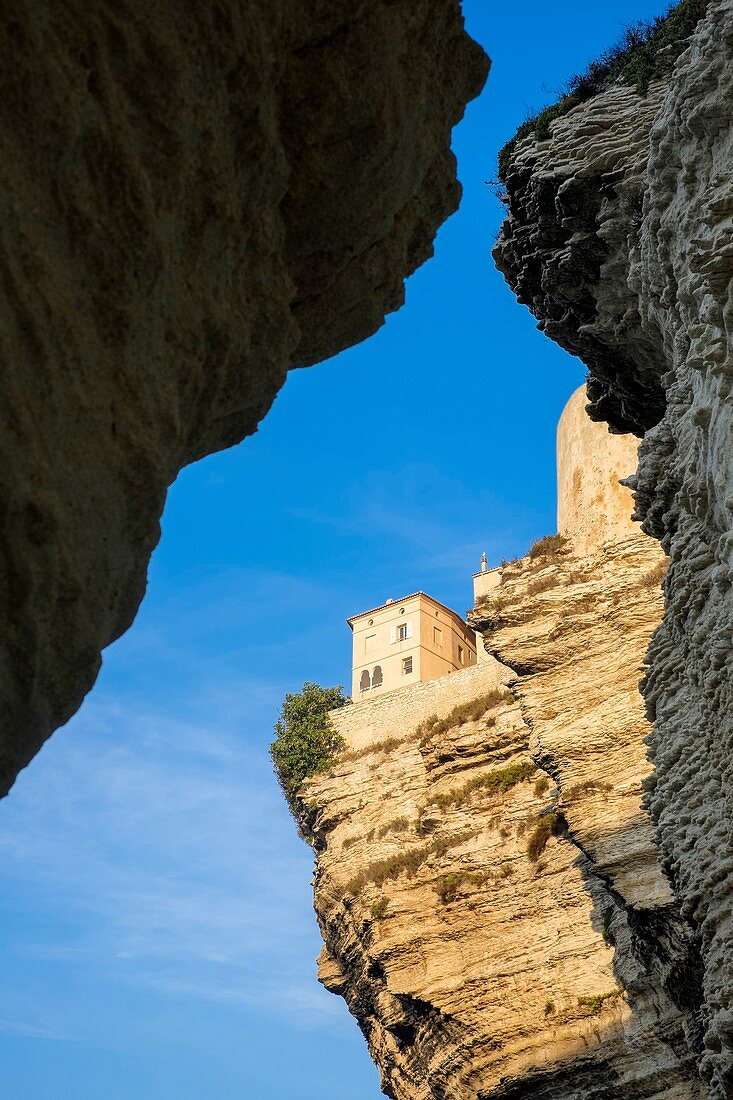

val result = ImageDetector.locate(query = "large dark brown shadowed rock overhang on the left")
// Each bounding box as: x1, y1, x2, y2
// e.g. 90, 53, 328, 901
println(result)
0, 0, 486, 793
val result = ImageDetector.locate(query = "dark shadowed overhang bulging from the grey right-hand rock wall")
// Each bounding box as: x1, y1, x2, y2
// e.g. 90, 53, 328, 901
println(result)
493, 81, 666, 433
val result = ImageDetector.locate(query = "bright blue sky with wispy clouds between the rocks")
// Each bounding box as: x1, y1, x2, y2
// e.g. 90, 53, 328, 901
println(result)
0, 0, 659, 1100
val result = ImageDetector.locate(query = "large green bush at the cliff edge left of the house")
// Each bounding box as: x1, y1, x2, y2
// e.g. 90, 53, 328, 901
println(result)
270, 683, 349, 828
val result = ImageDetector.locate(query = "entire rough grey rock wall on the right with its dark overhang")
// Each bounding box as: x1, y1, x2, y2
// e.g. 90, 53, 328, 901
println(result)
496, 0, 733, 1098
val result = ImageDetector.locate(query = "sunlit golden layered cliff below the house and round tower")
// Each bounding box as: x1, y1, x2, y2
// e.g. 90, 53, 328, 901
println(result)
304, 535, 704, 1100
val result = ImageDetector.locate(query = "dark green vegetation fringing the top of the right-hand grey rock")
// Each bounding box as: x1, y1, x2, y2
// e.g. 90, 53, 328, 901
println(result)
499, 0, 708, 183
